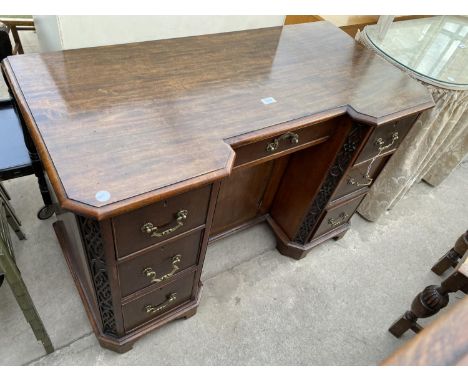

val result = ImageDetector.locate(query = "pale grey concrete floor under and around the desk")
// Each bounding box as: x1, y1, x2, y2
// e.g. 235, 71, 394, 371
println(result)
0, 28, 468, 365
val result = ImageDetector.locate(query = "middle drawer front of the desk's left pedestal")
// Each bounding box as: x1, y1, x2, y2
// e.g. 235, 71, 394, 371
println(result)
118, 230, 204, 297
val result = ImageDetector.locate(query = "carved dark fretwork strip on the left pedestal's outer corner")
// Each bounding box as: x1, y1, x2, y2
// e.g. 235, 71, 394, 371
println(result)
78, 216, 117, 335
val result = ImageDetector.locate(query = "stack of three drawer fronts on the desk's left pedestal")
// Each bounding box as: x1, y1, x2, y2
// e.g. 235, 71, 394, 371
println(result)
112, 185, 212, 332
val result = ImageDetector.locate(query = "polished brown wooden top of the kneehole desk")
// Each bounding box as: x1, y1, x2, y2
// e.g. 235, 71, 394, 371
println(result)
3, 22, 433, 218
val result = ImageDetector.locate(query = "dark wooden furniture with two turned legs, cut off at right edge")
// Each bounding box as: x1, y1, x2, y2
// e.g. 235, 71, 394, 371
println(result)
389, 231, 468, 338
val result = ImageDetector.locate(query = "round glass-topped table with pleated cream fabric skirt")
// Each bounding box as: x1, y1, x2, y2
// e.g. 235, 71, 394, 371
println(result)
356, 16, 468, 221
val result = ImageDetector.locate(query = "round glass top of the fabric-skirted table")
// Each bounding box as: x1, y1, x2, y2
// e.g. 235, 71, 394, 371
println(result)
365, 16, 468, 86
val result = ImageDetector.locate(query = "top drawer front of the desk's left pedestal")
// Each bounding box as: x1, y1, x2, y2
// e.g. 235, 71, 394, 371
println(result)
112, 185, 211, 257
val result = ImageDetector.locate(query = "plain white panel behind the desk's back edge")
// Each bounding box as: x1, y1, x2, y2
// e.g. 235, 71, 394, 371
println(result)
34, 16, 284, 51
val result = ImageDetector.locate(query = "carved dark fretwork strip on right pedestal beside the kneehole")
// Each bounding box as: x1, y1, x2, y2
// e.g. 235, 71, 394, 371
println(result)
294, 123, 367, 244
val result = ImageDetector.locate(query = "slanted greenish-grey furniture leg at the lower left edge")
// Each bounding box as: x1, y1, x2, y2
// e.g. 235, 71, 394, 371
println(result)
0, 200, 54, 353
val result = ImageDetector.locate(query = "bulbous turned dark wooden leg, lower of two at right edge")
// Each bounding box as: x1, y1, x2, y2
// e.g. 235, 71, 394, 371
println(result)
389, 264, 468, 338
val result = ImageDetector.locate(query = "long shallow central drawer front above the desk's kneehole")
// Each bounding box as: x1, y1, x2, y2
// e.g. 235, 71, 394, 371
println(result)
234, 120, 337, 167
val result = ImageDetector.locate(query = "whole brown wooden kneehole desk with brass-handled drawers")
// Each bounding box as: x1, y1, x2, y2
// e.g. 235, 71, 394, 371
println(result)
2, 22, 433, 352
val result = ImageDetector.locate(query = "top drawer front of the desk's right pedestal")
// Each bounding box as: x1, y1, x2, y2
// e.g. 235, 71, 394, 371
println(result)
355, 115, 417, 163
